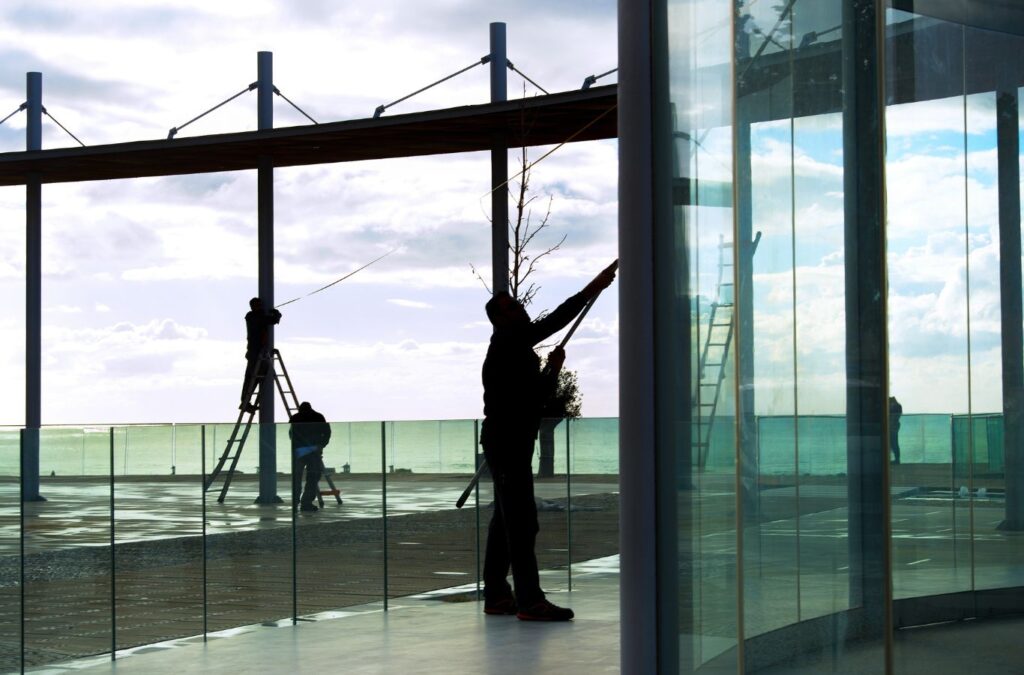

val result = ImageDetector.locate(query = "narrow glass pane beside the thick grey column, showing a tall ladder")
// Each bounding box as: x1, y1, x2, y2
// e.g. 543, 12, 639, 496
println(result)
667, 0, 739, 673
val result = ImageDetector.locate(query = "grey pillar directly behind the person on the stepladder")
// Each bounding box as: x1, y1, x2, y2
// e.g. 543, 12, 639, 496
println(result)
256, 51, 281, 504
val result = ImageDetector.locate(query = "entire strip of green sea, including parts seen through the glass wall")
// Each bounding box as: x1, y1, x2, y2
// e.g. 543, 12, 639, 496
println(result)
0, 415, 1002, 476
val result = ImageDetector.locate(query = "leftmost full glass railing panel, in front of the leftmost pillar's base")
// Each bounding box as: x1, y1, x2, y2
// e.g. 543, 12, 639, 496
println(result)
24, 427, 114, 668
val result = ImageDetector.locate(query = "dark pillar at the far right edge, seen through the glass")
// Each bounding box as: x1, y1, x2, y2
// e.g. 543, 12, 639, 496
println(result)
995, 80, 1024, 531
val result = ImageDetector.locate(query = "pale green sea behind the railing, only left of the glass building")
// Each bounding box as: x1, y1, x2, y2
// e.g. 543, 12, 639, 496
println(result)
0, 418, 618, 476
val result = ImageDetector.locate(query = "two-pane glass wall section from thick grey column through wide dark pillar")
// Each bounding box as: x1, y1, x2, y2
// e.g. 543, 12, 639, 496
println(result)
655, 0, 888, 672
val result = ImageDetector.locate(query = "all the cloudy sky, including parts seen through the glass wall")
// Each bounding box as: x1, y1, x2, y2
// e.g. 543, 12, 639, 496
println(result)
0, 0, 1015, 424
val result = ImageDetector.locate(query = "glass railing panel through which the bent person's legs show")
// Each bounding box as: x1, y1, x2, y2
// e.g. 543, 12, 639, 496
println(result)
289, 422, 385, 616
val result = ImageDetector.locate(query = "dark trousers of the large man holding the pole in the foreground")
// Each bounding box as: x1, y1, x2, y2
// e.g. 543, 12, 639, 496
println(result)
483, 439, 544, 606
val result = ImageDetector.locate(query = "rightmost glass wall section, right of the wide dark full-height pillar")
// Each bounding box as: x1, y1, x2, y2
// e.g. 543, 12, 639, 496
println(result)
886, 2, 1024, 655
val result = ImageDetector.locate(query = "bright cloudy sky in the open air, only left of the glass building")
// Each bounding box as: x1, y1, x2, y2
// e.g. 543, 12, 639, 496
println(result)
0, 0, 618, 424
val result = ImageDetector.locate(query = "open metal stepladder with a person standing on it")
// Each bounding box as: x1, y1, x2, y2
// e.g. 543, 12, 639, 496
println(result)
204, 349, 342, 507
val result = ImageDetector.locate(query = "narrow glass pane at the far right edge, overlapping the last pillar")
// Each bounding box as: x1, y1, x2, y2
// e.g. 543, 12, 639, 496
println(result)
955, 36, 1024, 598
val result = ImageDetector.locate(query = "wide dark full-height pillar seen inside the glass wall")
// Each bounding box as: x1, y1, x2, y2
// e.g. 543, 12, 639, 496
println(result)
843, 0, 892, 647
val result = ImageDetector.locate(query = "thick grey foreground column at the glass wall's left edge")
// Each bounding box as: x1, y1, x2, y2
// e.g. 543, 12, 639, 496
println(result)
618, 0, 659, 673
